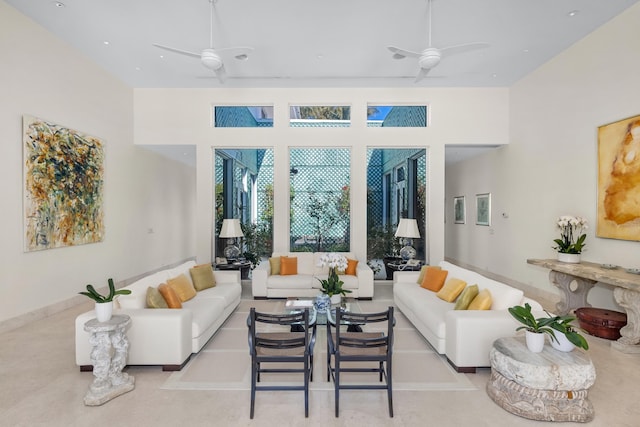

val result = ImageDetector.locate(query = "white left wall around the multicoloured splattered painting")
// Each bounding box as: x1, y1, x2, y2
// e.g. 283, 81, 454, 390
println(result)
0, 2, 195, 326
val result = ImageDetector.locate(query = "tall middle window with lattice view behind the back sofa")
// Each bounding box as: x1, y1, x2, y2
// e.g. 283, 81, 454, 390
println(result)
289, 148, 350, 252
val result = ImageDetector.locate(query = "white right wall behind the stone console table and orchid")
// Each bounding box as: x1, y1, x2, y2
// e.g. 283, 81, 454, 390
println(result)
445, 4, 640, 308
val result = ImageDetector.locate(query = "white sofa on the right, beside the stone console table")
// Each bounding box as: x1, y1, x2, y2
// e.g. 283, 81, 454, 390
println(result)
393, 261, 544, 372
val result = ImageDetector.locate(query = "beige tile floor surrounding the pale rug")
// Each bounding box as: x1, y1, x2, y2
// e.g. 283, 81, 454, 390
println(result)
0, 282, 640, 427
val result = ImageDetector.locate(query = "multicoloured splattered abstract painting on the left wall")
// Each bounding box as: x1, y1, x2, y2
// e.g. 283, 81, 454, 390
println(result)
23, 115, 104, 252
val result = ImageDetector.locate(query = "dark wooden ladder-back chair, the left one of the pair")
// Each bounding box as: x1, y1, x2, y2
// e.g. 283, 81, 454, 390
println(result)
247, 308, 316, 419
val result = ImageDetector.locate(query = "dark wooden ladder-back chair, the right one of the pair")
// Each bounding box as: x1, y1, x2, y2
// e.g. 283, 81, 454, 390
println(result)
327, 307, 395, 417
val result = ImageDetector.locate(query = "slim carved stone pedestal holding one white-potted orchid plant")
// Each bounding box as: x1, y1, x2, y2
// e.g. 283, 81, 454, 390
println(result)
84, 315, 135, 406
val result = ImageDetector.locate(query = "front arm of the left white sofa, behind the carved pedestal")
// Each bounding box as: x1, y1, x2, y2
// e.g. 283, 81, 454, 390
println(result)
76, 308, 192, 366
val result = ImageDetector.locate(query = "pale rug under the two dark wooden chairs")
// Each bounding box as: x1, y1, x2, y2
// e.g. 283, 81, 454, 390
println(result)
161, 300, 477, 391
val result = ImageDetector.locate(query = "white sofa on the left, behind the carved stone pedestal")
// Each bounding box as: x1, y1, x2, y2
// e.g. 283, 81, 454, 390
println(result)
76, 261, 242, 370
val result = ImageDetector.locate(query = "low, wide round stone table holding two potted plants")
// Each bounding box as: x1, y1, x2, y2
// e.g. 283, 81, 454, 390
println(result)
487, 337, 596, 422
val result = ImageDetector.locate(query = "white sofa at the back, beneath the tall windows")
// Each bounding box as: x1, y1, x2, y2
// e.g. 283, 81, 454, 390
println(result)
251, 252, 373, 299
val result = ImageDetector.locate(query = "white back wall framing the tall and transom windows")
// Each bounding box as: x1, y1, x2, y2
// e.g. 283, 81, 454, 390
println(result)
134, 88, 509, 263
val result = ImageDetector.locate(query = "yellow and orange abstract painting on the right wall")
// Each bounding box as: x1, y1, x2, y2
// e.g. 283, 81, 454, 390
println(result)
597, 116, 640, 240
